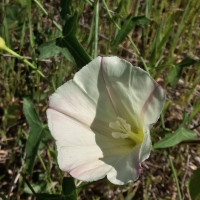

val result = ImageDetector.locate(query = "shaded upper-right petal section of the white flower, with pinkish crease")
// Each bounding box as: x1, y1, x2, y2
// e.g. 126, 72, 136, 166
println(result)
102, 57, 165, 129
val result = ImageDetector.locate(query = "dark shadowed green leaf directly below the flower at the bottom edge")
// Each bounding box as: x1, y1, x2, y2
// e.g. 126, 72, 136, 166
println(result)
62, 177, 77, 200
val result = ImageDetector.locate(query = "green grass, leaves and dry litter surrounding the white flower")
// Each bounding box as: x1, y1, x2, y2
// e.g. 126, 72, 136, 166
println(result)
0, 0, 200, 200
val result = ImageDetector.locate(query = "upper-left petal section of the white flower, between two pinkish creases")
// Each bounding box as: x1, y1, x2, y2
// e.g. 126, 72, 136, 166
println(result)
49, 57, 117, 137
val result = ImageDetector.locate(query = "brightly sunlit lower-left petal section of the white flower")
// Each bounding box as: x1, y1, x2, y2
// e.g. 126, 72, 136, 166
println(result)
47, 109, 134, 183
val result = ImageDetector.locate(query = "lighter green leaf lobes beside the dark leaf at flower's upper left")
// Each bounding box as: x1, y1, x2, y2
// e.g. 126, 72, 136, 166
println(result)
38, 39, 75, 65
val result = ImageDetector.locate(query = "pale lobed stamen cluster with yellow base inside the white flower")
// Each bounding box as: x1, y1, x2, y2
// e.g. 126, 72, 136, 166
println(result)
109, 117, 144, 145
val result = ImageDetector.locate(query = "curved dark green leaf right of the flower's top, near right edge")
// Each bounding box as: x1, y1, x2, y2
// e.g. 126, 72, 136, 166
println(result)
168, 57, 197, 87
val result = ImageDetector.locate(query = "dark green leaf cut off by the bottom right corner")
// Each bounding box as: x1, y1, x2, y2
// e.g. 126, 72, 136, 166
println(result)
189, 168, 200, 200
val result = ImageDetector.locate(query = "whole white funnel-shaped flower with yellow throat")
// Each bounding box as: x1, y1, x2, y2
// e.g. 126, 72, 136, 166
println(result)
47, 57, 165, 185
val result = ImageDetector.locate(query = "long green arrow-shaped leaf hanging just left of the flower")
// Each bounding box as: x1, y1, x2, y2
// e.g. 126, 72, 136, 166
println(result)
23, 99, 47, 175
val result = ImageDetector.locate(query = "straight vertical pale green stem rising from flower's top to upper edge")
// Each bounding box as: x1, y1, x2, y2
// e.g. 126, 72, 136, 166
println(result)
94, 0, 99, 58
